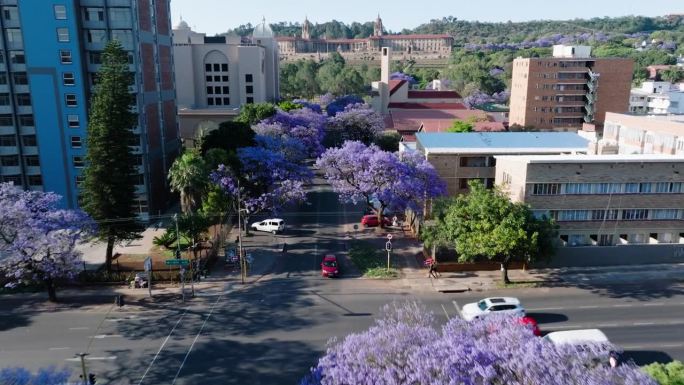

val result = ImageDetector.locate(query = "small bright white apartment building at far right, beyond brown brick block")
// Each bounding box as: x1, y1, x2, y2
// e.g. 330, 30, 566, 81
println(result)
629, 81, 684, 115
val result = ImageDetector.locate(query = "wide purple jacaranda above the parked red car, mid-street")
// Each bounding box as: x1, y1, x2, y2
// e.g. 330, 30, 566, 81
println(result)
316, 141, 446, 224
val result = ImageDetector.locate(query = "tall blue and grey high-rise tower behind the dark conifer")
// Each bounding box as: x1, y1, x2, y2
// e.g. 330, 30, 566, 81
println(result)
0, 0, 179, 218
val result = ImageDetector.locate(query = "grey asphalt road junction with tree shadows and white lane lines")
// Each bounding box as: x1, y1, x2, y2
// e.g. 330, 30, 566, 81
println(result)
0, 178, 684, 385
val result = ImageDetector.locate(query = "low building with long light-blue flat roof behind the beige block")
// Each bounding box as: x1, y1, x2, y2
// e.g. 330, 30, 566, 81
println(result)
415, 132, 589, 195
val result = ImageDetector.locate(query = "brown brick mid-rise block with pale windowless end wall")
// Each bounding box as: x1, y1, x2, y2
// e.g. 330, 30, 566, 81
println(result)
509, 45, 634, 131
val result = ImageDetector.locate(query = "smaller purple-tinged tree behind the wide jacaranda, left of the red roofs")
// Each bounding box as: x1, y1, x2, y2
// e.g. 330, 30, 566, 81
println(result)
326, 103, 385, 146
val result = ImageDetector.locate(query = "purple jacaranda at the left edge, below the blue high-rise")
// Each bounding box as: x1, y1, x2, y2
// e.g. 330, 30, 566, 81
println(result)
0, 183, 94, 301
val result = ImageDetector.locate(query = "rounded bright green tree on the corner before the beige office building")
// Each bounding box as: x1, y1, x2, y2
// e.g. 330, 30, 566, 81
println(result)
423, 180, 556, 283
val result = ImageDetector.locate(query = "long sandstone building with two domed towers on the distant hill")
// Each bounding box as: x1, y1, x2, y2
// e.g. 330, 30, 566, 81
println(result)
277, 15, 454, 60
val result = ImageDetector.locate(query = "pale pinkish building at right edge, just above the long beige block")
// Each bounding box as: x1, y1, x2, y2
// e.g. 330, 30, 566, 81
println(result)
596, 112, 684, 155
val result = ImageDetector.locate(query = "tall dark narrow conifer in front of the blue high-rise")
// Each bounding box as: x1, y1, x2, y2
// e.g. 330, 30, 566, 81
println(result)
82, 40, 143, 271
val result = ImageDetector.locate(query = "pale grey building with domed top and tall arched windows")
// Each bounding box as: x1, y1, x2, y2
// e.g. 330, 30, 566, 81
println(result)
173, 21, 280, 144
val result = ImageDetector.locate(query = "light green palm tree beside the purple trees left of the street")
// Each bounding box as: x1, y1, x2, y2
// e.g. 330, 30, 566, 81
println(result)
169, 150, 208, 214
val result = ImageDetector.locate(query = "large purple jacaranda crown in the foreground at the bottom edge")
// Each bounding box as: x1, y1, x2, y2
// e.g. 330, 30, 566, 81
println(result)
300, 303, 657, 385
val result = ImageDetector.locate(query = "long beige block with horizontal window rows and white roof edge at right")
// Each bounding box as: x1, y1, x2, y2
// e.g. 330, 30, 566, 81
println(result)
496, 155, 684, 248
